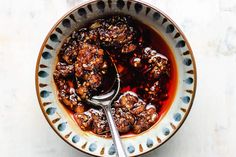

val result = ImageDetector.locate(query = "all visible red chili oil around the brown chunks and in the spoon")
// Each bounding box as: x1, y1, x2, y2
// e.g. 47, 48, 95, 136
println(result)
62, 15, 178, 137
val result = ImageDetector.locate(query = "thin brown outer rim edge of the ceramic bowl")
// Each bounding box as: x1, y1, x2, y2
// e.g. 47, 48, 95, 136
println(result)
35, 0, 197, 157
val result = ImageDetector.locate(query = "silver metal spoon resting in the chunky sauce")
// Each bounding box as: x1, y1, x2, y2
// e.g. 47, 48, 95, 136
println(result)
87, 55, 127, 157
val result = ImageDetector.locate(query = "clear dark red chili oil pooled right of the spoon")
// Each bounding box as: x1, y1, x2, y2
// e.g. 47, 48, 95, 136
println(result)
109, 21, 178, 137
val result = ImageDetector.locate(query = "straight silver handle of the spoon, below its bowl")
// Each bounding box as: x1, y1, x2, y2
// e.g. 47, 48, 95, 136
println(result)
103, 106, 127, 157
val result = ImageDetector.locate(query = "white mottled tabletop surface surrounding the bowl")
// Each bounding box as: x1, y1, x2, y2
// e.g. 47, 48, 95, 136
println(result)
0, 0, 236, 157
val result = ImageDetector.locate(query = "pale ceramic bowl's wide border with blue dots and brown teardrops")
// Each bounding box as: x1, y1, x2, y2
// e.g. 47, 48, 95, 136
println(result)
35, 0, 197, 156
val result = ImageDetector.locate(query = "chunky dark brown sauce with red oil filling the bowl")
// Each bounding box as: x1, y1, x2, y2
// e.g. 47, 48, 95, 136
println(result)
54, 15, 177, 137
